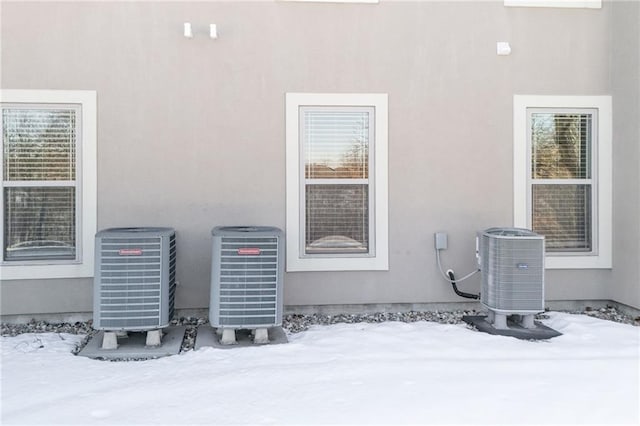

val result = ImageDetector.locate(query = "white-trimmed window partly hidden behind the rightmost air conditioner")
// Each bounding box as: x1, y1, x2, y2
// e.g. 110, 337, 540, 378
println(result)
514, 96, 612, 269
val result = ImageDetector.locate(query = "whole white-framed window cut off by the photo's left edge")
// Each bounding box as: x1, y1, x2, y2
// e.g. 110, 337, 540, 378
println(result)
0, 90, 96, 279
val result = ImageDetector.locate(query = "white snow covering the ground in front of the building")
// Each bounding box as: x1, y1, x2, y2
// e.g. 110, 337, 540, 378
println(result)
0, 313, 640, 425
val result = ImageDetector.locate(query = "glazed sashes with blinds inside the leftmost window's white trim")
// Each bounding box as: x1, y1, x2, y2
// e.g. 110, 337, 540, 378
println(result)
2, 106, 79, 261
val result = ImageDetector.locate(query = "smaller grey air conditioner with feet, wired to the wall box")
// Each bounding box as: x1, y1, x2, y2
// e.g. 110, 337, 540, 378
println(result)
478, 228, 544, 328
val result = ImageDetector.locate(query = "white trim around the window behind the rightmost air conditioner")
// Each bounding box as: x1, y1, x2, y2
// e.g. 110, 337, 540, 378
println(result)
513, 95, 613, 269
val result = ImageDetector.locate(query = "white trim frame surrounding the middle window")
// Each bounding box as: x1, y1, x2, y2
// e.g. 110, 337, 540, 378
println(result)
286, 93, 389, 271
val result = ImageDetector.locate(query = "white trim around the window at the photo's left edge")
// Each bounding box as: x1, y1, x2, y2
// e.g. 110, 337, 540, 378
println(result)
0, 89, 97, 280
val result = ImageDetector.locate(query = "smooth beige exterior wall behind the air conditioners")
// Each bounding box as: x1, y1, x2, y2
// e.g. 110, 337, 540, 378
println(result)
1, 1, 639, 314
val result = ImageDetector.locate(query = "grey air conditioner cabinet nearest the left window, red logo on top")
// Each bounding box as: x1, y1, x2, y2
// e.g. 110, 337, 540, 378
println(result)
93, 228, 176, 331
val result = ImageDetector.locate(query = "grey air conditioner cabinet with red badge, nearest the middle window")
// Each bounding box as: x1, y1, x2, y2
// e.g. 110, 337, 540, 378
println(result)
209, 226, 284, 329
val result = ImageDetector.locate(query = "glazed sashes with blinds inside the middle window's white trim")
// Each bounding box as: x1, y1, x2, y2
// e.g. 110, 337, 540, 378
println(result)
302, 107, 373, 254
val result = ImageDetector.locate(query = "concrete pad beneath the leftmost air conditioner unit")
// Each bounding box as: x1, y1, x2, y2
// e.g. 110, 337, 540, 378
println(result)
78, 326, 187, 360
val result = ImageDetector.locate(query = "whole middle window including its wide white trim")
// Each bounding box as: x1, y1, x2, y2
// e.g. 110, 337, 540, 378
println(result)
286, 93, 388, 271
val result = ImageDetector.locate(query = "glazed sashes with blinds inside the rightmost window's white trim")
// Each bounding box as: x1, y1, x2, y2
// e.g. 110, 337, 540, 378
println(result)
530, 111, 594, 252
